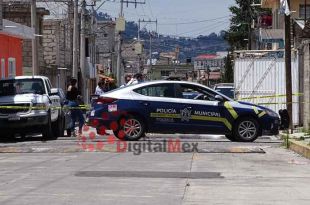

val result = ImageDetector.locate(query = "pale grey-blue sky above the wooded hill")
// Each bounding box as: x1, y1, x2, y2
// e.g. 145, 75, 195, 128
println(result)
98, 0, 235, 37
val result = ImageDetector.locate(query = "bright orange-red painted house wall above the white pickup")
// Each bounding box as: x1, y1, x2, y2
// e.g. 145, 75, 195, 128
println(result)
0, 34, 23, 78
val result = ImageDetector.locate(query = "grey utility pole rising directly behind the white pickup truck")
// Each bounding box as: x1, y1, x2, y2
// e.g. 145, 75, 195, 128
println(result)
31, 0, 38, 76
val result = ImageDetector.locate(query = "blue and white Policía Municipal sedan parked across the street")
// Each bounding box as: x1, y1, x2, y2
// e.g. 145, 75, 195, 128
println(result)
89, 81, 280, 142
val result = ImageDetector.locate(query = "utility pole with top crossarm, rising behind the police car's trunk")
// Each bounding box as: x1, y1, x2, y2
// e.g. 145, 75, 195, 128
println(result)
116, 0, 145, 86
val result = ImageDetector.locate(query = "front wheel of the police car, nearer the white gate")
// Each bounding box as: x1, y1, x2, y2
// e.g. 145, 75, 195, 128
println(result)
234, 117, 259, 142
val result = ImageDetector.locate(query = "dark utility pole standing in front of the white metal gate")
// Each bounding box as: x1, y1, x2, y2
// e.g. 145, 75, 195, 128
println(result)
285, 0, 293, 132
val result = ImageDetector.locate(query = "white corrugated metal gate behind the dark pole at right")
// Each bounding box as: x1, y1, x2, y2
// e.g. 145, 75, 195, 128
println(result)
234, 54, 299, 125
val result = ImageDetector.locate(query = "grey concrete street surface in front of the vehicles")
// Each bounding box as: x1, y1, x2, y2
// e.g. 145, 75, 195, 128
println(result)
0, 133, 310, 205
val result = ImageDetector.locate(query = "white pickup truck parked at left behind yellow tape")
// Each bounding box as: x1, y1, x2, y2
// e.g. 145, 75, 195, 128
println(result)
0, 76, 65, 140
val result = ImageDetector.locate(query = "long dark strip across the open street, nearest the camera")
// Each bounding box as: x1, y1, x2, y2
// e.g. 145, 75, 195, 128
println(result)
75, 171, 224, 179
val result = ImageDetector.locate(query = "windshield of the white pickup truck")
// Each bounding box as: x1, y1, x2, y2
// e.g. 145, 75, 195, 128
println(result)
0, 79, 46, 96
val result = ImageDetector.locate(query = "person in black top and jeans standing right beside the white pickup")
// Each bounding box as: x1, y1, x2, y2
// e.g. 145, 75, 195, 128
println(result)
67, 78, 85, 134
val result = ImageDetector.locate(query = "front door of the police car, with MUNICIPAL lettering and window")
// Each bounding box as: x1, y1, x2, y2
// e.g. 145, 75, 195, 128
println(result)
176, 83, 228, 134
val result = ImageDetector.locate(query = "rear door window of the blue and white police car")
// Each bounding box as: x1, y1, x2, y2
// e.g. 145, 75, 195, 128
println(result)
135, 84, 175, 98
